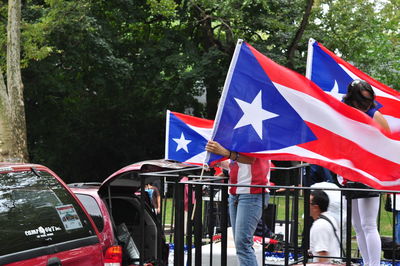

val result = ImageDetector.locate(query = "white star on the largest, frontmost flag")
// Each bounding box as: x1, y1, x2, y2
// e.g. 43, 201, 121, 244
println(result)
234, 90, 279, 139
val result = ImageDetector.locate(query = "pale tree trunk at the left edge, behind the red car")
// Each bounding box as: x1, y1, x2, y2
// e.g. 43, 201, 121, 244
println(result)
0, 0, 28, 162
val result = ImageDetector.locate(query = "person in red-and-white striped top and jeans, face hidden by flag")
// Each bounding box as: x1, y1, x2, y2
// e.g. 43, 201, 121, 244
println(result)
205, 140, 270, 266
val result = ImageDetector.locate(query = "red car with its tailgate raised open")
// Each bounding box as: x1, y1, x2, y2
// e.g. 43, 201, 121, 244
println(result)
69, 160, 197, 265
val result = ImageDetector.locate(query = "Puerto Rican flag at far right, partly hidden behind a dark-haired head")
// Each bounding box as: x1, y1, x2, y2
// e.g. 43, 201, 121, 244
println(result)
306, 39, 400, 136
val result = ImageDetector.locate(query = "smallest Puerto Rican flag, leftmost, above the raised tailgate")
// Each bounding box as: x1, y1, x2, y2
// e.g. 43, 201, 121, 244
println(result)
165, 110, 214, 165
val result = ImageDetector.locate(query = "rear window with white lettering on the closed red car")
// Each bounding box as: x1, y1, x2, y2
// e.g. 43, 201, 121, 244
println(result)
0, 171, 95, 256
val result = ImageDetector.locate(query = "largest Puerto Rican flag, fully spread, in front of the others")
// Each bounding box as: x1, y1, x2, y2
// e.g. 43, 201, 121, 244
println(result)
207, 40, 400, 189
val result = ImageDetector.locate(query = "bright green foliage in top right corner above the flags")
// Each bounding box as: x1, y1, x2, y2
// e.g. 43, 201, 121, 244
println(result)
308, 0, 400, 89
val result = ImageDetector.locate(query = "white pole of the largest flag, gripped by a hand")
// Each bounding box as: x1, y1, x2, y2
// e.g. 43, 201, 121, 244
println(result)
203, 39, 243, 166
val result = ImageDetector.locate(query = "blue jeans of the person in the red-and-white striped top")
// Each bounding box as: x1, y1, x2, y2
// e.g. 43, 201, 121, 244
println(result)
229, 193, 269, 266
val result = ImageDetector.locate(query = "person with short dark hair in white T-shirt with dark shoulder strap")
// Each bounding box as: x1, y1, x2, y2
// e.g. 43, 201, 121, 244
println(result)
310, 190, 341, 262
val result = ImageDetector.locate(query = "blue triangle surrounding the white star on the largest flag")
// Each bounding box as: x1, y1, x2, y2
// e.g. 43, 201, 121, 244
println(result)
214, 43, 316, 153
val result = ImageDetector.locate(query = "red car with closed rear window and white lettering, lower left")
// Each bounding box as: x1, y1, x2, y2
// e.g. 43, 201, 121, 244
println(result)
0, 163, 121, 266
